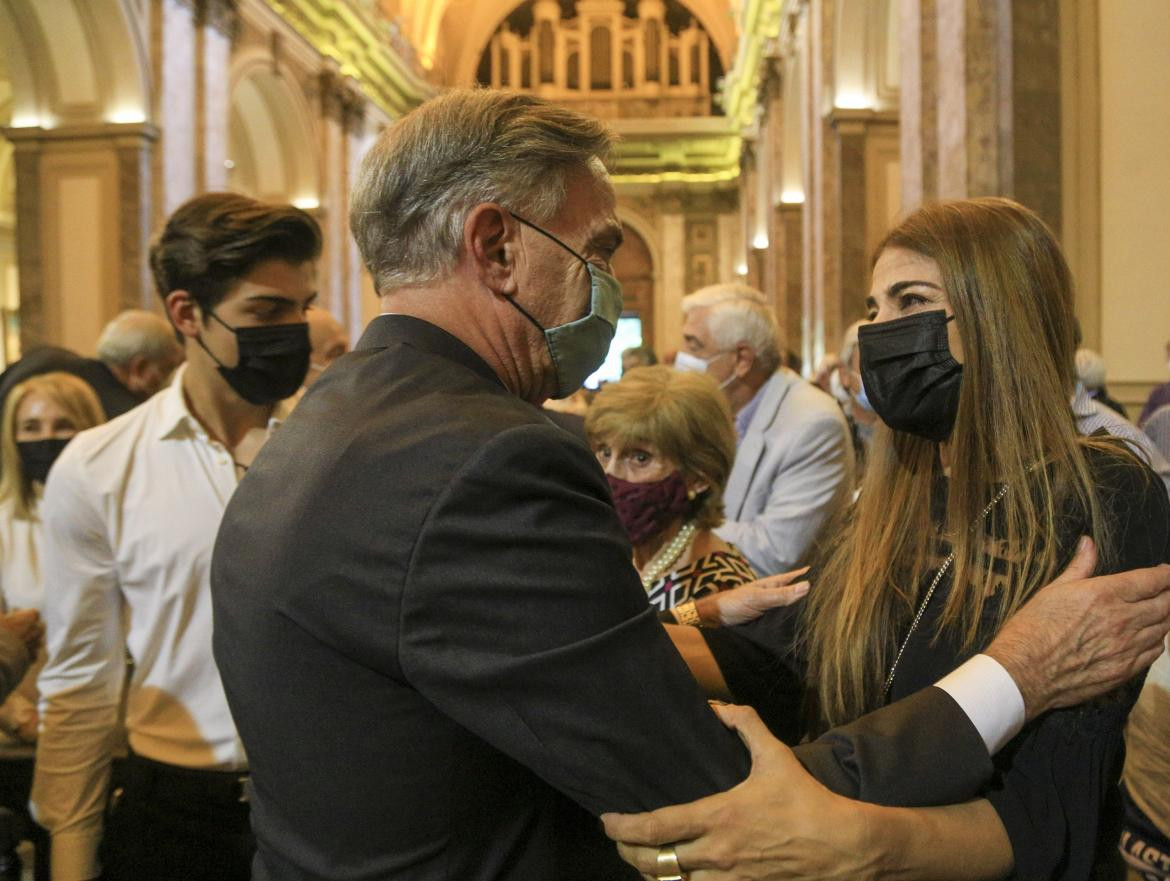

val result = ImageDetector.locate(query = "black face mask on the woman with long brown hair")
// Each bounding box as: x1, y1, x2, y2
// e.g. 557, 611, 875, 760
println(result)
858, 309, 963, 442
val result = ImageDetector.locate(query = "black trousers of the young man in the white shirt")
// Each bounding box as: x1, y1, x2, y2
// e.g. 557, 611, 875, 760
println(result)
101, 755, 256, 881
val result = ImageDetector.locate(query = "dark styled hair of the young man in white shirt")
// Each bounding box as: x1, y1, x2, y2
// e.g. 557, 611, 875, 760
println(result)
150, 193, 322, 314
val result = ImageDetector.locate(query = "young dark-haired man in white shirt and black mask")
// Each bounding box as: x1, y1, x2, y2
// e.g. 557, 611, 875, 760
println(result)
32, 193, 322, 881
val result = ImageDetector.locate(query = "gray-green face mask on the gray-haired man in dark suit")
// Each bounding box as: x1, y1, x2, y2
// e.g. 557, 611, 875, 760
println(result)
508, 214, 622, 398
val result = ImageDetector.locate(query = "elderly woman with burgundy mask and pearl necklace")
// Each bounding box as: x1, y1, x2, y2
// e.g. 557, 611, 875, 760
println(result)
585, 366, 756, 624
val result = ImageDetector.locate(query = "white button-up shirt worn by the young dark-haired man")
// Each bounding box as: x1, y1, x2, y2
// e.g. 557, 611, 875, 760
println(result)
32, 367, 283, 881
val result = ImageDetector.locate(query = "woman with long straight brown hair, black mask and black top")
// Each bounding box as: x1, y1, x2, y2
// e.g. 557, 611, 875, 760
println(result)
664, 199, 1170, 880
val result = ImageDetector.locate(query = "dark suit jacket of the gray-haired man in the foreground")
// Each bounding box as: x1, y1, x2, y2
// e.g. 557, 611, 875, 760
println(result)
212, 316, 996, 881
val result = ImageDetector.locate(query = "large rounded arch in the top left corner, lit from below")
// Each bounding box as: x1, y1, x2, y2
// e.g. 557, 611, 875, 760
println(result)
0, 0, 151, 129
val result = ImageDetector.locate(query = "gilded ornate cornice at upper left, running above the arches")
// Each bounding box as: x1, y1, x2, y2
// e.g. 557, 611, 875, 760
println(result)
263, 0, 434, 117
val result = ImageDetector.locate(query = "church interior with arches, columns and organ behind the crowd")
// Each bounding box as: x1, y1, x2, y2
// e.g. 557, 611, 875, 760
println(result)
0, 0, 1170, 405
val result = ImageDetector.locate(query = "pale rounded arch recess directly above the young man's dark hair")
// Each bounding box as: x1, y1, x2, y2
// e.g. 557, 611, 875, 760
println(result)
228, 50, 319, 208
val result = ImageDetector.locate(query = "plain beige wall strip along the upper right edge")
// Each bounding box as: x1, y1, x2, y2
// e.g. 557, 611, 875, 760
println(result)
1099, 0, 1170, 399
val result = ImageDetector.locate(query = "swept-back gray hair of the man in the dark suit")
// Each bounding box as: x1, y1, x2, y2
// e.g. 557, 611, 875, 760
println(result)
350, 89, 614, 292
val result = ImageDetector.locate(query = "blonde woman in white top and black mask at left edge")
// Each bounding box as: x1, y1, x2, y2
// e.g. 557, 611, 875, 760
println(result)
0, 372, 105, 877
